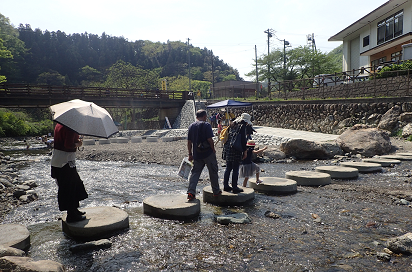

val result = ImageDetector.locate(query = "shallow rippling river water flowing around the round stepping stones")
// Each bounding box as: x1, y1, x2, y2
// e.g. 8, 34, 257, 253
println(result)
3, 150, 412, 271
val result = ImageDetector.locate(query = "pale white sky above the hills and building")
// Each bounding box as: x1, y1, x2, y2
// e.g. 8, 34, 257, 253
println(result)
0, 0, 388, 80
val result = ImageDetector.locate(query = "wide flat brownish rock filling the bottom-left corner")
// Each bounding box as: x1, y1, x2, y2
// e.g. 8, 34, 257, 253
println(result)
0, 256, 65, 272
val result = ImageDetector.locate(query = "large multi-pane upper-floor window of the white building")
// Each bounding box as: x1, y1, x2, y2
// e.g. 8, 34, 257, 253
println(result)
378, 10, 403, 44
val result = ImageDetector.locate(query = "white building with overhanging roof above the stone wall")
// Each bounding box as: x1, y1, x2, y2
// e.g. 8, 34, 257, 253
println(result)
329, 0, 412, 71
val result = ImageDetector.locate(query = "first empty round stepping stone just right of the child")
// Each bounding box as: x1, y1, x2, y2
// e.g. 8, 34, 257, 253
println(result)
249, 177, 298, 194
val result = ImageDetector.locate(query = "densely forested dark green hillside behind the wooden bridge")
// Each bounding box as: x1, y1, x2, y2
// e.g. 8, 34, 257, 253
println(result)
0, 14, 240, 91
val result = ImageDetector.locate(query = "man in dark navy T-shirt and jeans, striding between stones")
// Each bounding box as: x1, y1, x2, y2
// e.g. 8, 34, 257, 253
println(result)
187, 110, 222, 200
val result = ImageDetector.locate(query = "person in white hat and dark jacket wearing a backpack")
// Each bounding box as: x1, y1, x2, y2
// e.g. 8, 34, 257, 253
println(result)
222, 113, 252, 194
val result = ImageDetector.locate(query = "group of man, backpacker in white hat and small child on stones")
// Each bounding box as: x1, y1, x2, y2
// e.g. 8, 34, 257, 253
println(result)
187, 110, 266, 200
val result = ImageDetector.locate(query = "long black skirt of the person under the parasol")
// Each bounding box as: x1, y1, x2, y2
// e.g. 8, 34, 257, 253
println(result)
51, 163, 88, 211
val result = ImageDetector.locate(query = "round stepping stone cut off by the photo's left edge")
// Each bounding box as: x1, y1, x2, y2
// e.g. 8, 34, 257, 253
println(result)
0, 224, 30, 250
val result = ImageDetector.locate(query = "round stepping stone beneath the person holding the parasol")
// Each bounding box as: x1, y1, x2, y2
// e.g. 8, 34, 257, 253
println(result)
62, 207, 129, 241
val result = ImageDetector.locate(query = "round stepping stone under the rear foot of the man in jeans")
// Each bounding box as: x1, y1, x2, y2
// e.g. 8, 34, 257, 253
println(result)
143, 195, 200, 220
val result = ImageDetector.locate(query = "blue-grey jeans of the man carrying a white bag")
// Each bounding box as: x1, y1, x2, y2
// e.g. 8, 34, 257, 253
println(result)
187, 153, 220, 195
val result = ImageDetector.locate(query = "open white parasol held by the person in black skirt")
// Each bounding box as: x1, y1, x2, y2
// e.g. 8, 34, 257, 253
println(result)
50, 99, 119, 138
